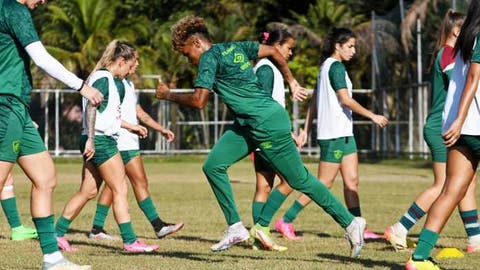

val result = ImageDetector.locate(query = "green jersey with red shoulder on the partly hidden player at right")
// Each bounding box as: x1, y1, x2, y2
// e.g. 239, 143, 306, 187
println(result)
425, 45, 455, 130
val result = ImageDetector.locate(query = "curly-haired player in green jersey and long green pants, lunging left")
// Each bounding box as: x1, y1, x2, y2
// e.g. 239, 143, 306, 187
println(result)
156, 16, 365, 257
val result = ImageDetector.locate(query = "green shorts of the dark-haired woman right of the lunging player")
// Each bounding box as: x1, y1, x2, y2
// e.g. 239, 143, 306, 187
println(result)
318, 136, 357, 163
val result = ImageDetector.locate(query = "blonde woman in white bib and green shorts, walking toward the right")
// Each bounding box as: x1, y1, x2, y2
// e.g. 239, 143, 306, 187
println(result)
55, 40, 158, 252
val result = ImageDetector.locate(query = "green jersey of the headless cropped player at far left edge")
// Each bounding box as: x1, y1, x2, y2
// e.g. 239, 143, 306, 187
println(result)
0, 0, 40, 105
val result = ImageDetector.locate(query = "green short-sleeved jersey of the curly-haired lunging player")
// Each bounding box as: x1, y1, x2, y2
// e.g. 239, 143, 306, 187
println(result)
194, 41, 283, 127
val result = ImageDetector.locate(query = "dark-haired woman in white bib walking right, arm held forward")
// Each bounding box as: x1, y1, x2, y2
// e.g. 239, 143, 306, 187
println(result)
276, 28, 388, 238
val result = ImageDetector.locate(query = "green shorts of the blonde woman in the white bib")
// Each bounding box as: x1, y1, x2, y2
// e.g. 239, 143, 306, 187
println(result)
80, 135, 118, 167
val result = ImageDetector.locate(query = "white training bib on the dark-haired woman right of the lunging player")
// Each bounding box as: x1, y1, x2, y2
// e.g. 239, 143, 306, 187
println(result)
316, 57, 353, 140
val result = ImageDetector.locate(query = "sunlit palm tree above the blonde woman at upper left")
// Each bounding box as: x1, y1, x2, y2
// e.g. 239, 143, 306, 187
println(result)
42, 0, 149, 78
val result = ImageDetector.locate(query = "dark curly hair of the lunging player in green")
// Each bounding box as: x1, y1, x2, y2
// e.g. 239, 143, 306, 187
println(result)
172, 16, 210, 51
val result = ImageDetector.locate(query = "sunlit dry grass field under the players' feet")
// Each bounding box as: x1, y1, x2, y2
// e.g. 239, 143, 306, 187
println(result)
0, 156, 480, 270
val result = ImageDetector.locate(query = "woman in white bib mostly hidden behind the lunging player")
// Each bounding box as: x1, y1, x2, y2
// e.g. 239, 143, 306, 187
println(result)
252, 28, 297, 247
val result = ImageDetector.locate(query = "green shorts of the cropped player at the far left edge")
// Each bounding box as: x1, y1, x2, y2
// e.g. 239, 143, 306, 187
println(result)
0, 95, 47, 163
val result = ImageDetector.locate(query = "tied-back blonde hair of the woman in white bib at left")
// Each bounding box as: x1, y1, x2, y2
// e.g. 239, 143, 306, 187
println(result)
93, 39, 137, 71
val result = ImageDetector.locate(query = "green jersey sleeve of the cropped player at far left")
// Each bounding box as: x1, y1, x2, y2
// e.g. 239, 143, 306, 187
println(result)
6, 3, 40, 48
